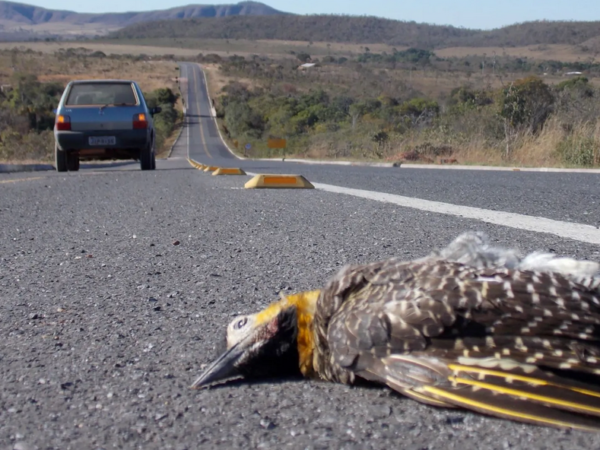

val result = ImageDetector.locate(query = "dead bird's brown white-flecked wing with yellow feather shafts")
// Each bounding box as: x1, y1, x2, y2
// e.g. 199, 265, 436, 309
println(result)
317, 260, 600, 430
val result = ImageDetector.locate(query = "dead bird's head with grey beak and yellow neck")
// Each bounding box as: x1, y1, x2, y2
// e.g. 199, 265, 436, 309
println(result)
192, 290, 320, 388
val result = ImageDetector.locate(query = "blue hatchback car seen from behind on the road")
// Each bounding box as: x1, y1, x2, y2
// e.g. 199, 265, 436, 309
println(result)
54, 80, 161, 172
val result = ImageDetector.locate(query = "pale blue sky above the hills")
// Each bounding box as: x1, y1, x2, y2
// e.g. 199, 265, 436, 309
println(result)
22, 0, 600, 29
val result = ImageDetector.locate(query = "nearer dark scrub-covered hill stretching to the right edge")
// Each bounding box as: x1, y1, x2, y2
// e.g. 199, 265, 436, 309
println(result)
109, 15, 600, 48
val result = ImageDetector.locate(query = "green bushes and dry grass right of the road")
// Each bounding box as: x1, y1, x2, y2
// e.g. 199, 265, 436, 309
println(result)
205, 49, 600, 167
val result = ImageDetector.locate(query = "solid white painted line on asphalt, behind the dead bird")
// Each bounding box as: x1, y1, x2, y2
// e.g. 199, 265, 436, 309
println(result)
312, 183, 600, 245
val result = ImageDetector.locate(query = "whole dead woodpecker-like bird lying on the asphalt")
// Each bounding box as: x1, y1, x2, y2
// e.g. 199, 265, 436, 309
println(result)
194, 234, 600, 430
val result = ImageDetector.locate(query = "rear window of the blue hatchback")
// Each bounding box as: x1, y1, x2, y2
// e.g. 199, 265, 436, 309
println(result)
66, 83, 137, 106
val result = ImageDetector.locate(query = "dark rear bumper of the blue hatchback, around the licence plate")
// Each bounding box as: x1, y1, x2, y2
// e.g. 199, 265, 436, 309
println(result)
54, 130, 149, 150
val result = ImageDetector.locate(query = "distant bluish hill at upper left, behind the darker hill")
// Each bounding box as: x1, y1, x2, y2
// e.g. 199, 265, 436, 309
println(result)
0, 1, 286, 36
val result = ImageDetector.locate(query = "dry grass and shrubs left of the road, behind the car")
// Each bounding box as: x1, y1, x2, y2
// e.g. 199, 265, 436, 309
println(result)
0, 49, 182, 162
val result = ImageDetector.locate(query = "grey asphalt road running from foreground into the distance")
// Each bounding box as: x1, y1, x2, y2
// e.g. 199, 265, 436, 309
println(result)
0, 66, 600, 450
